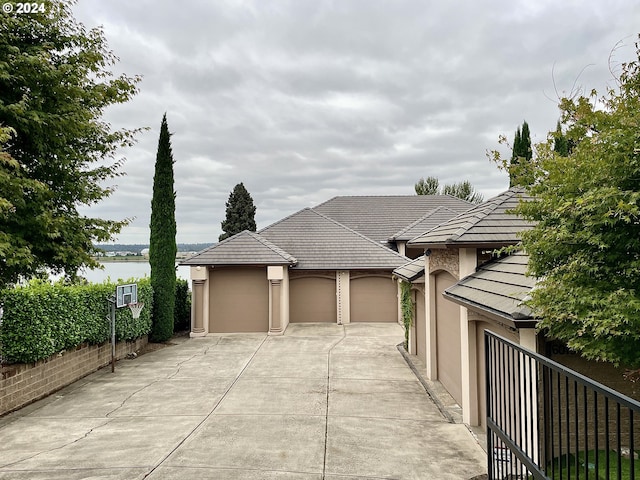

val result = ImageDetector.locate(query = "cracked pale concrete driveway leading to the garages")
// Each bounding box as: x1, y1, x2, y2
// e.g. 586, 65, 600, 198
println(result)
0, 324, 486, 480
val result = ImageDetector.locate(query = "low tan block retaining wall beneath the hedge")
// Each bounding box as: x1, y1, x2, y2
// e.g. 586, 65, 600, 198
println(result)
0, 336, 148, 416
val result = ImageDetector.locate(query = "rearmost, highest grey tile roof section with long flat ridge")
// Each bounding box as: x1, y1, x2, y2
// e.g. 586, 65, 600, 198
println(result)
313, 195, 473, 244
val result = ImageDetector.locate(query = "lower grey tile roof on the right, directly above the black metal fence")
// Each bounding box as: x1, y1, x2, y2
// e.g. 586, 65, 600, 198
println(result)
443, 252, 536, 323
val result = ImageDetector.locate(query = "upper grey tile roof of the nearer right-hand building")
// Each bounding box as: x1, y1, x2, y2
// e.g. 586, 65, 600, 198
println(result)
407, 187, 533, 247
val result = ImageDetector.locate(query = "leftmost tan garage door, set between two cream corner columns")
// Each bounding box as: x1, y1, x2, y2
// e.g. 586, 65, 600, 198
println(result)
209, 267, 269, 333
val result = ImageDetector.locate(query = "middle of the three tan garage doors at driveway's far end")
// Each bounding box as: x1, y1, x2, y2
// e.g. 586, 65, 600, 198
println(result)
289, 277, 338, 323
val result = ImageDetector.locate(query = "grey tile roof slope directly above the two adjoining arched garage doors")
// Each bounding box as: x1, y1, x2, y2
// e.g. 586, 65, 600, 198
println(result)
258, 208, 408, 270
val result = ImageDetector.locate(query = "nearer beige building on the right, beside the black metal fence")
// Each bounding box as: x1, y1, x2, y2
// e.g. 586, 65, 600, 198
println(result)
393, 187, 536, 425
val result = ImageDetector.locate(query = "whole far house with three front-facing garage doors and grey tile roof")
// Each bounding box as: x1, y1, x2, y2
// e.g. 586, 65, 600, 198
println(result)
181, 195, 471, 336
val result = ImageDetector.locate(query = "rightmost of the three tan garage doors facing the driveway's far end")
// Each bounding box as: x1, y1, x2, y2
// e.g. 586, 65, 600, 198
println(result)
349, 276, 398, 322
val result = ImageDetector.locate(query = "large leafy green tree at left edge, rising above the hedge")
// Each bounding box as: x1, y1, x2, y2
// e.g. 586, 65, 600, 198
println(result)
0, 0, 139, 286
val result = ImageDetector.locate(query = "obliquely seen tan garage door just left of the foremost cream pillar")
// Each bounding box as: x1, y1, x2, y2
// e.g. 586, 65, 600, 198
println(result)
435, 272, 462, 405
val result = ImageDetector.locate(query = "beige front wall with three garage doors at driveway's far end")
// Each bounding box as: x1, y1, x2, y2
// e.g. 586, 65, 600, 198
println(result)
191, 265, 399, 337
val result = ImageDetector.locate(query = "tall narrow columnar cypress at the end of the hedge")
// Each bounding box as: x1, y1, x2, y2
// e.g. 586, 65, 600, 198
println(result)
149, 113, 178, 342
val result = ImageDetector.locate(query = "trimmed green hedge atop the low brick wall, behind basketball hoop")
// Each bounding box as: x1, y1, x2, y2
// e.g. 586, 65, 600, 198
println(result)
0, 278, 153, 363
